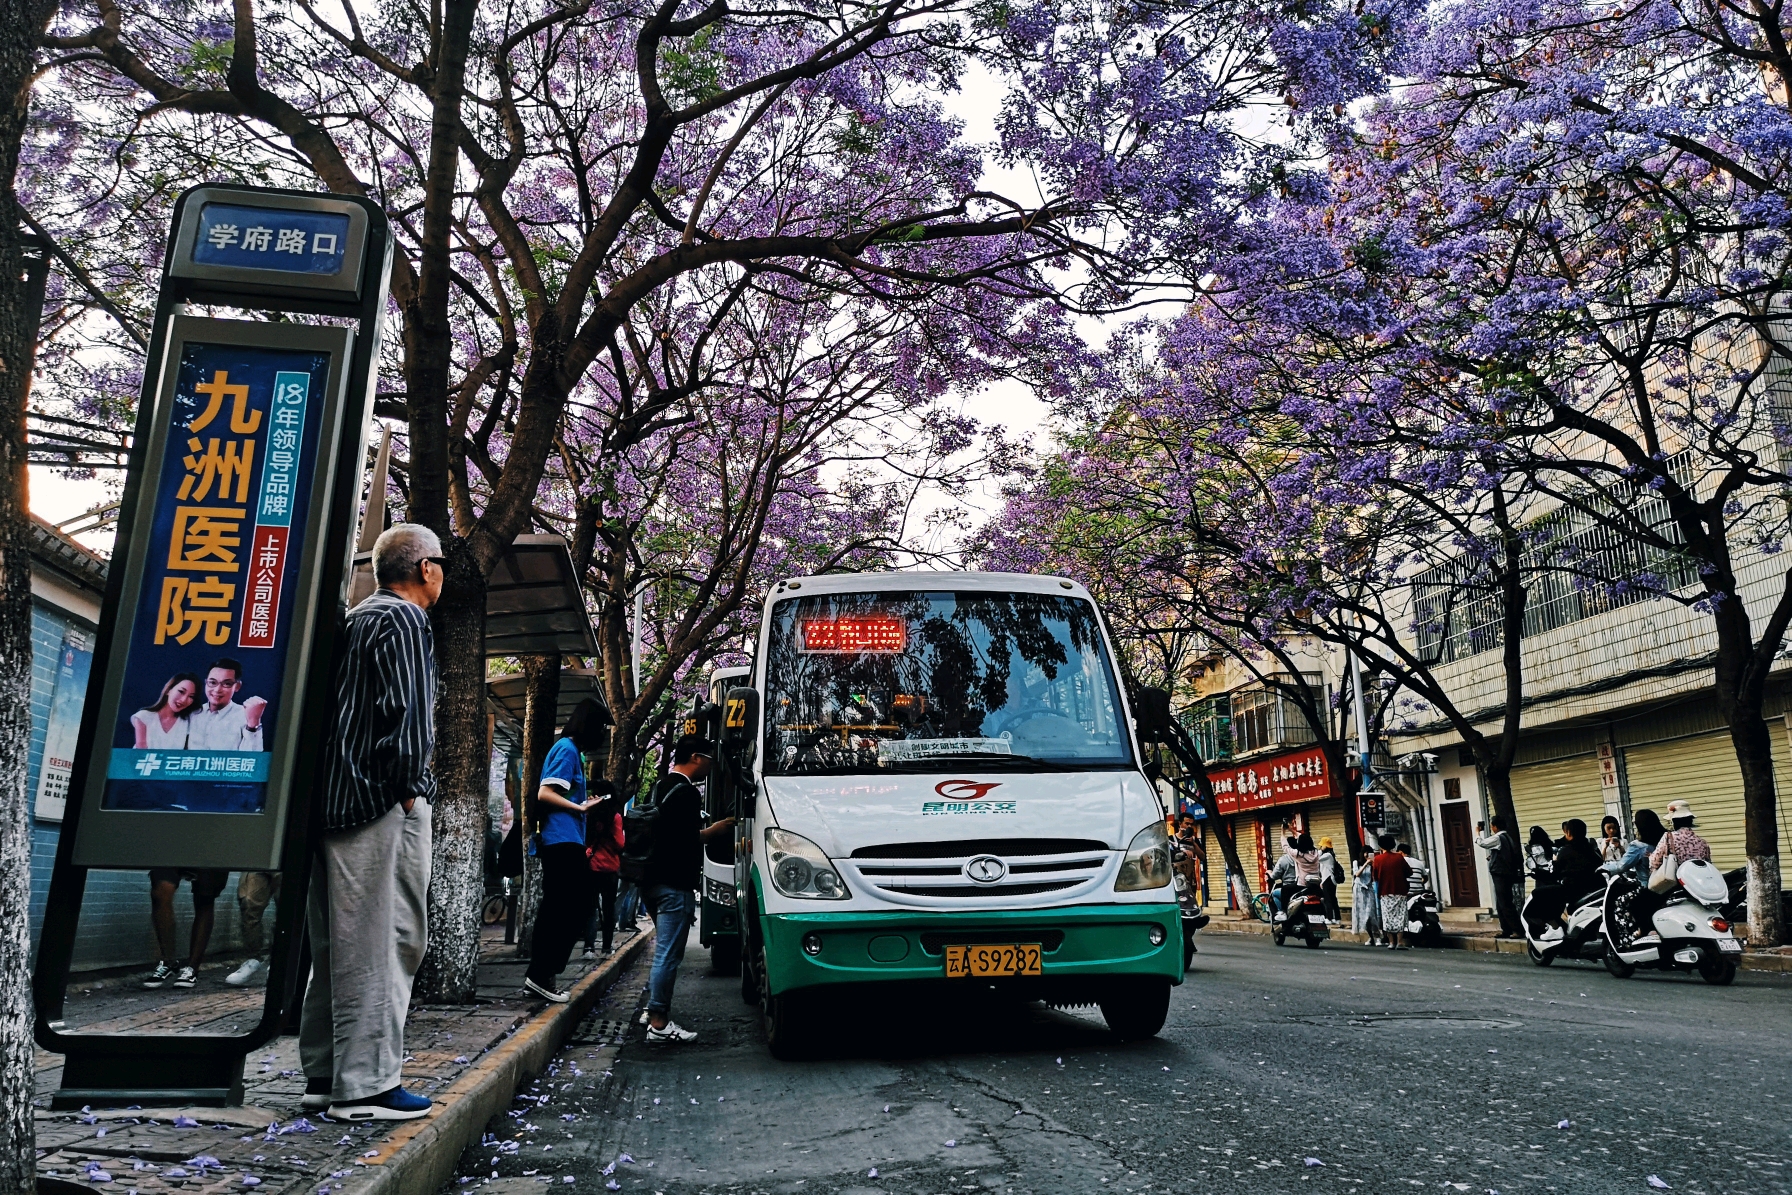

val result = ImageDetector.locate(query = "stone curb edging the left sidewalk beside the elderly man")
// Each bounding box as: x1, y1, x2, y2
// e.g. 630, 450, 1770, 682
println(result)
342, 930, 654, 1195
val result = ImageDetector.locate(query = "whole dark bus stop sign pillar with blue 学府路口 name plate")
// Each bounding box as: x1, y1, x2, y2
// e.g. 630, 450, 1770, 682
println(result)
32, 186, 392, 1107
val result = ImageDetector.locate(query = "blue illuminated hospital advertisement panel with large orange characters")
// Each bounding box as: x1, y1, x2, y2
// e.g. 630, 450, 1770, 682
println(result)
81, 317, 349, 865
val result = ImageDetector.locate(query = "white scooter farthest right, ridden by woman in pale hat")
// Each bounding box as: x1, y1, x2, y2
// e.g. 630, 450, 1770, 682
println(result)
1602, 858, 1742, 987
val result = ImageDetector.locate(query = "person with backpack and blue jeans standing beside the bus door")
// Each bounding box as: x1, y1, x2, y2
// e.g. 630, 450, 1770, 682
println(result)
622, 735, 735, 1043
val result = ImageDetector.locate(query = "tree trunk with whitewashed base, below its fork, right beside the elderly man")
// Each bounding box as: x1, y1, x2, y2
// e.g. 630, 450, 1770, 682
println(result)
416, 566, 491, 1003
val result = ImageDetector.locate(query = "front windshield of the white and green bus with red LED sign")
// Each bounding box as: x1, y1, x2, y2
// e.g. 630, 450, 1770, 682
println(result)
765, 593, 1131, 776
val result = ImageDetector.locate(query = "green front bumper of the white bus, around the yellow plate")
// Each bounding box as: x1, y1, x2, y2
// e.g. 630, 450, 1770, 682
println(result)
758, 903, 1183, 993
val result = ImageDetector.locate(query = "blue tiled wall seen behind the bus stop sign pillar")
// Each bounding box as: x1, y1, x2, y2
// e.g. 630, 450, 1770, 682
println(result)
25, 602, 252, 971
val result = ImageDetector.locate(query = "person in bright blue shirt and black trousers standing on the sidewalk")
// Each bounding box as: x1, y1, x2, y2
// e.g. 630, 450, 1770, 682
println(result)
523, 697, 609, 1003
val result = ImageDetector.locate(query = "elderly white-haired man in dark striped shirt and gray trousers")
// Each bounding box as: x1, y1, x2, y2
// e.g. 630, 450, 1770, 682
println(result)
299, 523, 446, 1120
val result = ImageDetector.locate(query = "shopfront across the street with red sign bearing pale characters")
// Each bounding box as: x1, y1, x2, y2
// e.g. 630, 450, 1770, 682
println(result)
1202, 747, 1349, 908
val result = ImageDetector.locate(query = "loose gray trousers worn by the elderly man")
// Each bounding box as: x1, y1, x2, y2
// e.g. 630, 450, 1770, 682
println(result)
299, 801, 430, 1100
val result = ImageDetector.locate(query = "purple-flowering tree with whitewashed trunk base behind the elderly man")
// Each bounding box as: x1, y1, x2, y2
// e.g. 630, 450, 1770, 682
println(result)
27, 0, 1362, 1000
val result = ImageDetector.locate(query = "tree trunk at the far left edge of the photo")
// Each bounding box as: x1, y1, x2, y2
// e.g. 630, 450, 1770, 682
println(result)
0, 0, 54, 1175
